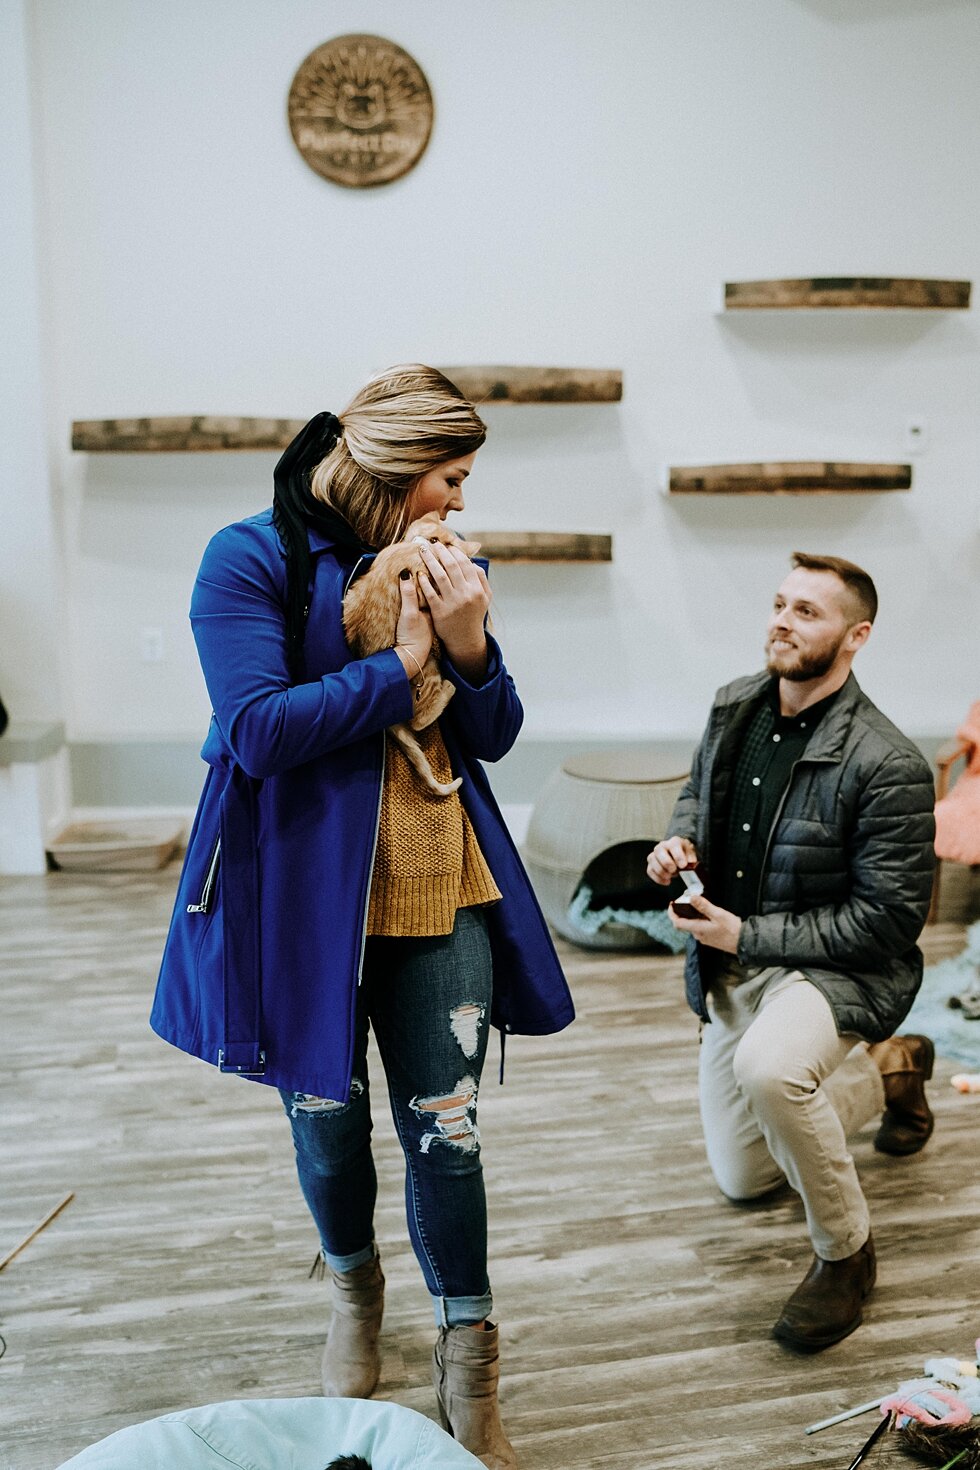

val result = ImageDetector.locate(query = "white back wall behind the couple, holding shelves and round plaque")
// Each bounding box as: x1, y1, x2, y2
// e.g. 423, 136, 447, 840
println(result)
13, 0, 980, 741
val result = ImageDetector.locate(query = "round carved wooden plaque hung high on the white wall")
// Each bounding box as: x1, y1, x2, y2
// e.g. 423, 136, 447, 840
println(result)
289, 35, 432, 188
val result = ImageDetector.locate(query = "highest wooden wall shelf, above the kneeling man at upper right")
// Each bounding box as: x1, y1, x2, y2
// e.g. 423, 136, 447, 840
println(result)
724, 276, 971, 312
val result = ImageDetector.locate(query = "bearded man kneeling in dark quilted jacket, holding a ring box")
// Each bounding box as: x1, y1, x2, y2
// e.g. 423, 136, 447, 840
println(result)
646, 551, 934, 1351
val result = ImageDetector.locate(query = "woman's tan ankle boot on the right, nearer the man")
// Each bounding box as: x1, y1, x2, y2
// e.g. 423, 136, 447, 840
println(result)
432, 1326, 517, 1470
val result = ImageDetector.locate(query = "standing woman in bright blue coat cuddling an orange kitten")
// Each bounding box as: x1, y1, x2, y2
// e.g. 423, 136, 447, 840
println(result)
151, 365, 573, 1470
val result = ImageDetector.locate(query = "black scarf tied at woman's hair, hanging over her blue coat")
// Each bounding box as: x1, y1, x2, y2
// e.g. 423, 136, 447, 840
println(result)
272, 413, 373, 676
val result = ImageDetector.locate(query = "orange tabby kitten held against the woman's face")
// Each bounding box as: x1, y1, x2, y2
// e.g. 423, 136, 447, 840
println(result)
344, 510, 479, 797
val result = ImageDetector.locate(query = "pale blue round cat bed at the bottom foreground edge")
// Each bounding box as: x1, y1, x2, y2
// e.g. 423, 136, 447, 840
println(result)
59, 1398, 480, 1470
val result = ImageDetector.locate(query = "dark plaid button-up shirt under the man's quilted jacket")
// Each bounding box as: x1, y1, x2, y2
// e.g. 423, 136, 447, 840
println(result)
716, 679, 840, 919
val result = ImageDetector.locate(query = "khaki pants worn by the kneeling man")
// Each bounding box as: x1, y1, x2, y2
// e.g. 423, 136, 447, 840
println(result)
699, 961, 884, 1261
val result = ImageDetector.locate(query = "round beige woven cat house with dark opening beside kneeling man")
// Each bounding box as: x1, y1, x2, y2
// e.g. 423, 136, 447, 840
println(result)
523, 747, 688, 950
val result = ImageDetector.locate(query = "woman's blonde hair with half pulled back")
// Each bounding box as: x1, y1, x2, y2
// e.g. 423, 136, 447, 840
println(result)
310, 363, 486, 547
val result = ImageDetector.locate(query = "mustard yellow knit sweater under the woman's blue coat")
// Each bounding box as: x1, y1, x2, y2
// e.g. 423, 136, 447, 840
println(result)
367, 720, 501, 936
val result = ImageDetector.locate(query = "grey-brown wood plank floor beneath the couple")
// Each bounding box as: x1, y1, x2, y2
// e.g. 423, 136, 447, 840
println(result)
0, 867, 980, 1470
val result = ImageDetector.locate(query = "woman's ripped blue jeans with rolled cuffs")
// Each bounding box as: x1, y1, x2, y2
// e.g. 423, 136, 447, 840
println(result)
281, 908, 492, 1327
